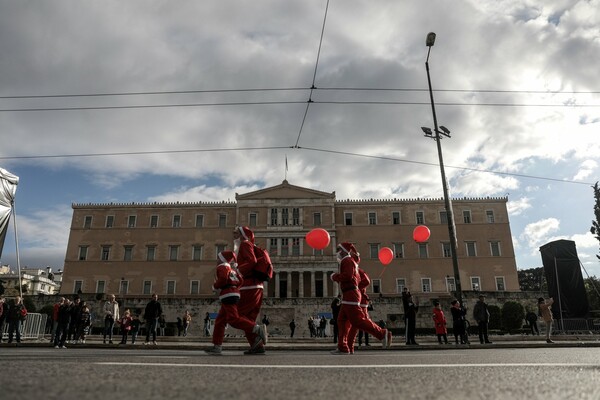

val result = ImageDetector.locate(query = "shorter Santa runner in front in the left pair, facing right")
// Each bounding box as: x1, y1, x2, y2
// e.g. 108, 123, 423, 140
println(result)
205, 250, 267, 355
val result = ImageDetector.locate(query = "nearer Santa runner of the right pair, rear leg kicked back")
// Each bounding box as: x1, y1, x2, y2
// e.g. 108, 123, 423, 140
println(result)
331, 242, 392, 354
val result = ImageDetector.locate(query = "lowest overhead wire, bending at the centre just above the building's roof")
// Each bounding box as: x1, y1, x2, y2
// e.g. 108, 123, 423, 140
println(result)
0, 145, 594, 186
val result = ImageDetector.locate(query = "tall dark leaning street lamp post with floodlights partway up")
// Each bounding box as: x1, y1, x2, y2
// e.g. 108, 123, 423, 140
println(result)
421, 32, 462, 304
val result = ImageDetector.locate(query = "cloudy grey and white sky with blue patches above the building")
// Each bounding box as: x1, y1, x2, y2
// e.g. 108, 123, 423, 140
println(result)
0, 0, 600, 276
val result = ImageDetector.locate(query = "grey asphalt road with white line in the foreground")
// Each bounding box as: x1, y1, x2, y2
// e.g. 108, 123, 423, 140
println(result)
0, 347, 600, 400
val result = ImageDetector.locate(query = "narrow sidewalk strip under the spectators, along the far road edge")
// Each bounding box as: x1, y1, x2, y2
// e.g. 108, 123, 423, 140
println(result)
5, 335, 600, 352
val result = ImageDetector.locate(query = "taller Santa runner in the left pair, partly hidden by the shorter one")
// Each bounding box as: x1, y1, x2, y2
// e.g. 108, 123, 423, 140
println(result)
215, 226, 267, 354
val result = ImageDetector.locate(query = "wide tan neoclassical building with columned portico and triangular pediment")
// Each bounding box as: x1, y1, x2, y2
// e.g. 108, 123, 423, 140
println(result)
61, 181, 519, 299
